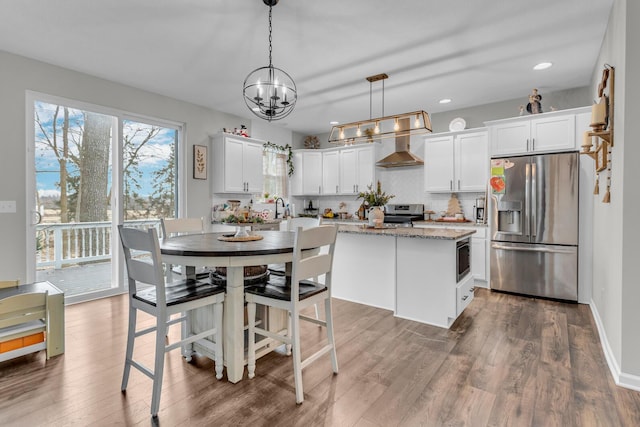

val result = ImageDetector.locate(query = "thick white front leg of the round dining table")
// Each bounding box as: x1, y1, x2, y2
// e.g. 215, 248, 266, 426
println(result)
224, 266, 245, 383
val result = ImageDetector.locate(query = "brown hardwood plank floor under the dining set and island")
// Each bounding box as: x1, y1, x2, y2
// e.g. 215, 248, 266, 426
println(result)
0, 289, 640, 427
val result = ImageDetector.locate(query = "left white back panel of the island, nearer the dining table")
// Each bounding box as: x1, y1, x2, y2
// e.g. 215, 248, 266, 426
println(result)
332, 233, 396, 310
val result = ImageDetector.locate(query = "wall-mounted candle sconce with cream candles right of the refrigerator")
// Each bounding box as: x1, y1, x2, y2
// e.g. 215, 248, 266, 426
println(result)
580, 64, 616, 203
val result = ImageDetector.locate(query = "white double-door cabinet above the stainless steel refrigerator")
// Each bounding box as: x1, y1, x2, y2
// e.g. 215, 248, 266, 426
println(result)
486, 112, 576, 156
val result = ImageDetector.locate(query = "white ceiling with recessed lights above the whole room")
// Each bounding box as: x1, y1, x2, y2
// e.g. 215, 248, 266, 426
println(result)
0, 0, 613, 134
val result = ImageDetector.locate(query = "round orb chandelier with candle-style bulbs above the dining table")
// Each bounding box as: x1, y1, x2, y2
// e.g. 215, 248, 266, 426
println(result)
242, 0, 298, 121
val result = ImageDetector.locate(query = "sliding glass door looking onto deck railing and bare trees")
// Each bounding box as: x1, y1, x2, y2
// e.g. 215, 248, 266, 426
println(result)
27, 94, 180, 302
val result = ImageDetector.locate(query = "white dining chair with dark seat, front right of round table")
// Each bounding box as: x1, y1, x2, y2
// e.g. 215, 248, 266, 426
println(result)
245, 225, 338, 403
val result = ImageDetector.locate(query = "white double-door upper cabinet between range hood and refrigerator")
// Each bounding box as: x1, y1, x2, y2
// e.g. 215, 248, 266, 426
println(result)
424, 130, 489, 193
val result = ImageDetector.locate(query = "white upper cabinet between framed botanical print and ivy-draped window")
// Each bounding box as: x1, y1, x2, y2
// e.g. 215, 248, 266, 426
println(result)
213, 134, 264, 193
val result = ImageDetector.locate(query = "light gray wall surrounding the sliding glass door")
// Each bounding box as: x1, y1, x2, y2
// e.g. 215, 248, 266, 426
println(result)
0, 51, 248, 281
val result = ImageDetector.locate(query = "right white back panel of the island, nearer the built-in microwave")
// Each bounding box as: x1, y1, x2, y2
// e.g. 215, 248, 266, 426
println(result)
396, 237, 456, 328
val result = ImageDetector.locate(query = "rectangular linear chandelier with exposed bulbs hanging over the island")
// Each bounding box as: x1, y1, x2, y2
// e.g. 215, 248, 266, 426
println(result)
329, 73, 431, 145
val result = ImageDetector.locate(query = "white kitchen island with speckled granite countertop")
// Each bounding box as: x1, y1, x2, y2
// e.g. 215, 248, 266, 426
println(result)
332, 225, 475, 328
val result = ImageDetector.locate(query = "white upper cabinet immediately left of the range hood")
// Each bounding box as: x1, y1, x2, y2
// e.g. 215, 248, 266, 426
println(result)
340, 146, 375, 194
